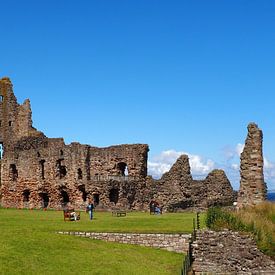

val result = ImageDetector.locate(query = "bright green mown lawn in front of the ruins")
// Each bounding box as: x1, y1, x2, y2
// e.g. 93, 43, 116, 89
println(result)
0, 208, 204, 274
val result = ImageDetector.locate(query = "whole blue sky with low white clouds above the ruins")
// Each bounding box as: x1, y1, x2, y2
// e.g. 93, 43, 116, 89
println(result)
0, 0, 275, 189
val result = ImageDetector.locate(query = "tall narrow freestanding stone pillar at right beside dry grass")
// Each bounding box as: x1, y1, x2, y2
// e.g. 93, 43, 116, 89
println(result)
238, 123, 266, 208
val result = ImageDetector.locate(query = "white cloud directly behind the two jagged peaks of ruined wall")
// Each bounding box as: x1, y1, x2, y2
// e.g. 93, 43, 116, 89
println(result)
148, 150, 215, 178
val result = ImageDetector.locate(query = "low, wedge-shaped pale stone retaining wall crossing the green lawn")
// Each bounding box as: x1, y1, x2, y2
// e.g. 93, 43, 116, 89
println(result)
58, 232, 191, 253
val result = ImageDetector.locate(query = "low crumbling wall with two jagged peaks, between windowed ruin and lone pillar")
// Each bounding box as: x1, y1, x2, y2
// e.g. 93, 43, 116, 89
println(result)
147, 155, 234, 211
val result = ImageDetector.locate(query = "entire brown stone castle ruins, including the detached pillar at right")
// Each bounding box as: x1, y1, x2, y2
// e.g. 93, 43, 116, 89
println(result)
0, 78, 266, 211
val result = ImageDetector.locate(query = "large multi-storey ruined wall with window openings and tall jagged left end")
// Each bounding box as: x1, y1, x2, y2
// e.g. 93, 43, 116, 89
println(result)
0, 78, 149, 209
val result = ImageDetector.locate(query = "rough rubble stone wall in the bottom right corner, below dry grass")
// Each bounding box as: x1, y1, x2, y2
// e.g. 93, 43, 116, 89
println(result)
191, 231, 275, 275
